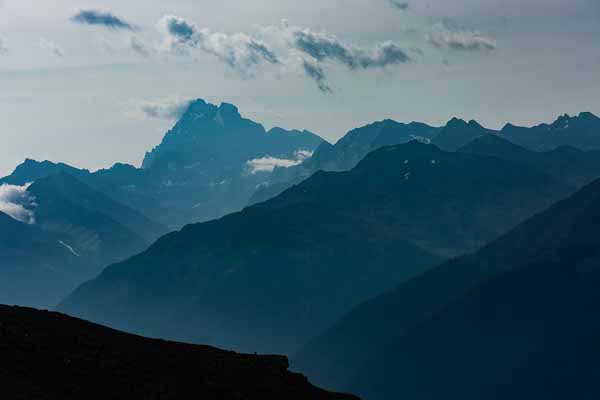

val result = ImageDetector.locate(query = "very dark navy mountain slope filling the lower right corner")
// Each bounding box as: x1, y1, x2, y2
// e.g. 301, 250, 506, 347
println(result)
294, 176, 600, 400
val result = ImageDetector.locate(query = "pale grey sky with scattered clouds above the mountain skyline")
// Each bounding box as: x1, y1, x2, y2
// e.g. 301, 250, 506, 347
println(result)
0, 0, 600, 175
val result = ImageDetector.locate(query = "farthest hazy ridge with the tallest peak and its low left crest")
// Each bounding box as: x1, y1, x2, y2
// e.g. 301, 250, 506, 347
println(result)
0, 100, 324, 229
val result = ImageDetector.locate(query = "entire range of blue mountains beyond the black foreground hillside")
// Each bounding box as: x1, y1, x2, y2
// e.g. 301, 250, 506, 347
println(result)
0, 100, 600, 400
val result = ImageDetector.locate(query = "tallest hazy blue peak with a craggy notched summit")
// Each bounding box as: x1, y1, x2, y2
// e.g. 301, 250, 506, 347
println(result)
138, 100, 322, 225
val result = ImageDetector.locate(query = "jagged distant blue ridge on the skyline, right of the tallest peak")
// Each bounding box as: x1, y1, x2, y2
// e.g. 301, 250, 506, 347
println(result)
250, 113, 600, 204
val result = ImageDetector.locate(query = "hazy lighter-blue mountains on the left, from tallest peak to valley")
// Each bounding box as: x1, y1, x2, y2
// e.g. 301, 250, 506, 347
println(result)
0, 100, 323, 307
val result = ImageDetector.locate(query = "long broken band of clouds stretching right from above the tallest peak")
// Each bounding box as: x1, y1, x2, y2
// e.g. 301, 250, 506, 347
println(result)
157, 15, 418, 93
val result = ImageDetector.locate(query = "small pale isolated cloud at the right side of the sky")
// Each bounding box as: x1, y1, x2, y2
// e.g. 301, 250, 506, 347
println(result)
427, 21, 496, 51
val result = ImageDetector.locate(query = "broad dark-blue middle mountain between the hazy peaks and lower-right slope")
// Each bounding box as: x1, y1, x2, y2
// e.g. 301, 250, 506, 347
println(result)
60, 141, 571, 353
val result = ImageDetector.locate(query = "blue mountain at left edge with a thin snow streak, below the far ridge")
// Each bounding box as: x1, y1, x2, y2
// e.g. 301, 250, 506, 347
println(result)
0, 172, 166, 307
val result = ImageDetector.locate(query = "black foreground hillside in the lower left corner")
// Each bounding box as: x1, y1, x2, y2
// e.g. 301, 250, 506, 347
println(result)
0, 306, 355, 400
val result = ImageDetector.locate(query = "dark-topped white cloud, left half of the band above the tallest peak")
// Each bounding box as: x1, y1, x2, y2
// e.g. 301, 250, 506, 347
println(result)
158, 15, 280, 74
